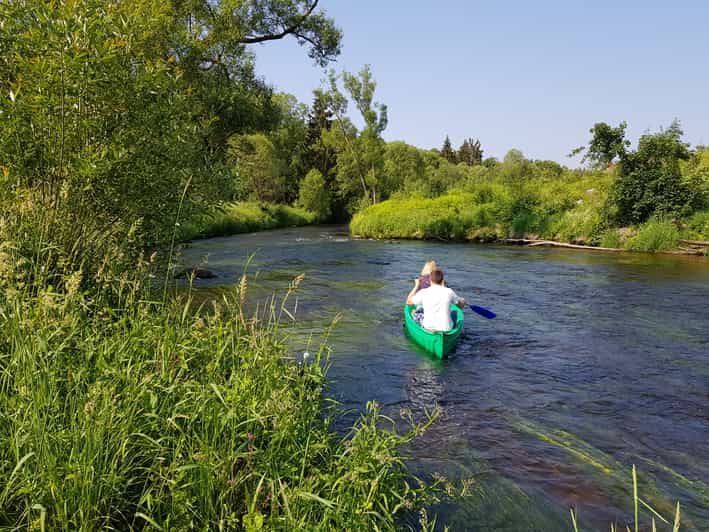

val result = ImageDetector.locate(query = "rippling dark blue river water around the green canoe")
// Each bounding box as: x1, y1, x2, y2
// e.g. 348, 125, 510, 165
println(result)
185, 227, 709, 530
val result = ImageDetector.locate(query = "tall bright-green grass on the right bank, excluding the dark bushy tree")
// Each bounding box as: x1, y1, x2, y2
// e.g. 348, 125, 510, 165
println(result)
350, 177, 709, 252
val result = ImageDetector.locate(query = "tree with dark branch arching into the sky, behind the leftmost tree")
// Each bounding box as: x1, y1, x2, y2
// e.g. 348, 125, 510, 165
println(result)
156, 0, 342, 157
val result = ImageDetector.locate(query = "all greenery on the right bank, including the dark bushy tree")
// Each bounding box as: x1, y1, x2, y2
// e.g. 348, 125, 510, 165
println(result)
350, 122, 709, 251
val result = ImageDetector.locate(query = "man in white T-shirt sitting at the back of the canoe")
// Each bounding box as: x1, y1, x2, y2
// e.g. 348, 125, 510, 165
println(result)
406, 269, 465, 332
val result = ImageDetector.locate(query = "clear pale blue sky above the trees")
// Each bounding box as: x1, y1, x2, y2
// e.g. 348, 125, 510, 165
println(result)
252, 0, 709, 166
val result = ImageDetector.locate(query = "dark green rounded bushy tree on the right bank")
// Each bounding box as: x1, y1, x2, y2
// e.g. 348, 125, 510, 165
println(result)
611, 120, 694, 224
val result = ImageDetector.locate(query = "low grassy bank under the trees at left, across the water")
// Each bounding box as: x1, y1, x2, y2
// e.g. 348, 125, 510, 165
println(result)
178, 201, 317, 241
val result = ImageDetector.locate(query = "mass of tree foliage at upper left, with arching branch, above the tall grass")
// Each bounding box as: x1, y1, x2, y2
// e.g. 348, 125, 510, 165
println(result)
0, 0, 341, 286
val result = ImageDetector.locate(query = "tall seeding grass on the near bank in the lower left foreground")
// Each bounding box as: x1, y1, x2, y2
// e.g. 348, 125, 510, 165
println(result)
0, 270, 440, 530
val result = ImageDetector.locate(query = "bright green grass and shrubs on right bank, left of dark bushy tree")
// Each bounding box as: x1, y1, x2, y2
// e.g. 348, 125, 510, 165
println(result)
350, 163, 612, 243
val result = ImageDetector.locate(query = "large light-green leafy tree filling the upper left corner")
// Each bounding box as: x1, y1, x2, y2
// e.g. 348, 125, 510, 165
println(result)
0, 0, 209, 280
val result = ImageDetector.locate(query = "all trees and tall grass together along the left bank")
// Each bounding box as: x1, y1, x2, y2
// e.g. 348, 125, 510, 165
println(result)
0, 0, 442, 530
